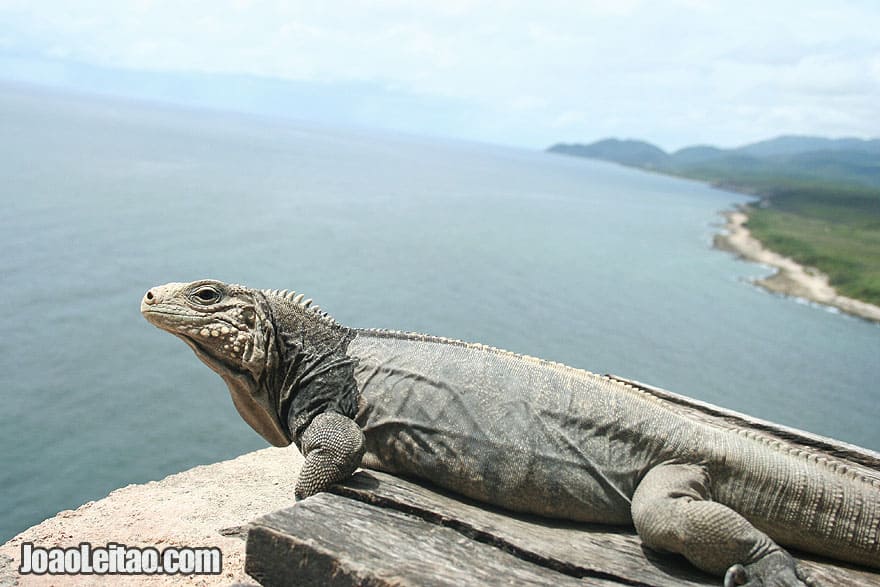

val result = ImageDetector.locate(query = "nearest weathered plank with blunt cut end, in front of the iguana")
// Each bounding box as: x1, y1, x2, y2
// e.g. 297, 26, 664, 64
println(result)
245, 493, 620, 587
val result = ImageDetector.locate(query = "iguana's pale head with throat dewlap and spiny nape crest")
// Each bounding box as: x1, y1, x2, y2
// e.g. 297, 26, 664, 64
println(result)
141, 279, 338, 446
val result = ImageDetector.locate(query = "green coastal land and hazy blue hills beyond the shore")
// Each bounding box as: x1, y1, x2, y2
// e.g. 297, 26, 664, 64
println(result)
549, 137, 880, 305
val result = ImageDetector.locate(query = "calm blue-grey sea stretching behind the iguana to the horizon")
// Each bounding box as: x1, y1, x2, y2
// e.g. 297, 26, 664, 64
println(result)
0, 86, 880, 541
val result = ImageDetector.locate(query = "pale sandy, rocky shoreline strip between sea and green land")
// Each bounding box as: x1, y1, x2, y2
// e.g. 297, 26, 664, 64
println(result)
713, 208, 880, 323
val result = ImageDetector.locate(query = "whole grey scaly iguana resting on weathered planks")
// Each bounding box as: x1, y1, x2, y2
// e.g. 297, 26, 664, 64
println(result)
141, 280, 880, 585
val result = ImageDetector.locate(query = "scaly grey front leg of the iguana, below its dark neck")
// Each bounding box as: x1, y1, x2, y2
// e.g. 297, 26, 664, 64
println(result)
294, 412, 364, 499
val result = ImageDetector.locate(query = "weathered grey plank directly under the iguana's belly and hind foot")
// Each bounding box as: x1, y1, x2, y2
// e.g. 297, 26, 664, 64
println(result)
332, 471, 880, 587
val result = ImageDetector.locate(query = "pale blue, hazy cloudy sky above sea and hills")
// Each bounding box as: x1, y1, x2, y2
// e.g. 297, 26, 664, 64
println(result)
0, 0, 880, 150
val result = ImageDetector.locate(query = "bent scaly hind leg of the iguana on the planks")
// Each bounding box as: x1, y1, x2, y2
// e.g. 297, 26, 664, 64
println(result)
632, 464, 808, 587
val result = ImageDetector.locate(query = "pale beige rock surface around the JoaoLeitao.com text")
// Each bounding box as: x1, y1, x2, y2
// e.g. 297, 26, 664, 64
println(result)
0, 448, 302, 587
